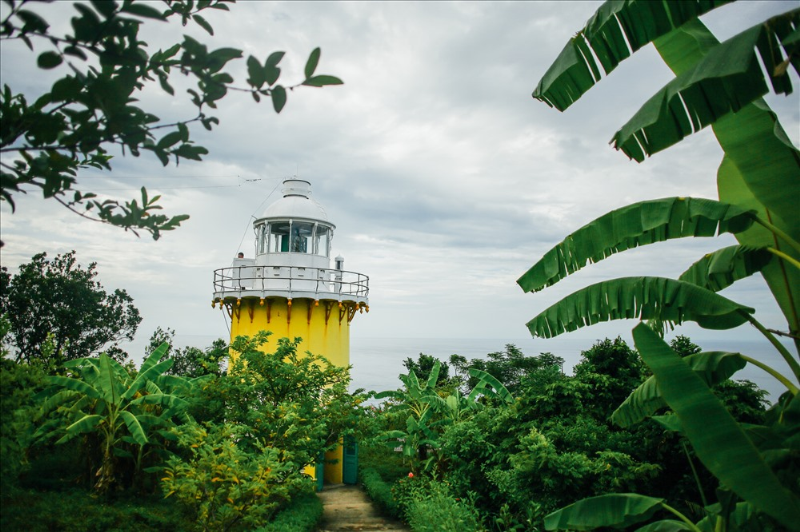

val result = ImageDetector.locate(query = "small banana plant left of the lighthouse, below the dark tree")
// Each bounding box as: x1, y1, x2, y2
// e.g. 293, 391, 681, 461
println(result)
36, 343, 188, 493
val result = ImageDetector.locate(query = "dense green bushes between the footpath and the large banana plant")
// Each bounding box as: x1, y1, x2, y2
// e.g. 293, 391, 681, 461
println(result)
368, 337, 765, 532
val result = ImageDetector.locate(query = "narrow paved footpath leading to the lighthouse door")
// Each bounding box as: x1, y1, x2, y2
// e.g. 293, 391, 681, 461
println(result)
317, 484, 411, 532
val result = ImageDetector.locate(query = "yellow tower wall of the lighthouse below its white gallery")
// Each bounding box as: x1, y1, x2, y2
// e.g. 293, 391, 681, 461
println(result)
225, 299, 350, 484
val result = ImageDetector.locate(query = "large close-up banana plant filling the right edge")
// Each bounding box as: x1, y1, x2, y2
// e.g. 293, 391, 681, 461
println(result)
518, 0, 800, 530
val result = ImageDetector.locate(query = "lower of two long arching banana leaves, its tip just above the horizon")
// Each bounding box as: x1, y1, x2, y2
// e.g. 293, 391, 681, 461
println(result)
527, 277, 754, 338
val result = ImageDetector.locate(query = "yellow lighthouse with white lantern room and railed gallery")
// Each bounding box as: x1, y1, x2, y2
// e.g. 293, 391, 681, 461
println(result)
212, 179, 369, 483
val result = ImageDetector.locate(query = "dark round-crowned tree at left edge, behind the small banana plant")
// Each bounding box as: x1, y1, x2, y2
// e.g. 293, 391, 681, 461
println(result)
0, 251, 142, 366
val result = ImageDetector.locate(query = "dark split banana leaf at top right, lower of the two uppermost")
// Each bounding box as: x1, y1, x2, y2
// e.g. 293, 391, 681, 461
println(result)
611, 10, 800, 162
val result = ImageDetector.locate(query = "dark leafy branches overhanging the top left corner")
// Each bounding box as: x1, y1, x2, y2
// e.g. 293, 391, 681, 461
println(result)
0, 0, 342, 239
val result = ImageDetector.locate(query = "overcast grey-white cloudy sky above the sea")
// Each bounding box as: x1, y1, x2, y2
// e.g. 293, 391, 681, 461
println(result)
0, 1, 800, 370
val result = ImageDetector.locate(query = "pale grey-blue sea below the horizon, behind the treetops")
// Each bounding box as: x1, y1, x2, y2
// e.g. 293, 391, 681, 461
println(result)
350, 336, 793, 402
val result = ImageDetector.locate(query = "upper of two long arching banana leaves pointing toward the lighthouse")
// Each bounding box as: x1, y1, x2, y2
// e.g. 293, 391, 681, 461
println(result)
517, 197, 753, 292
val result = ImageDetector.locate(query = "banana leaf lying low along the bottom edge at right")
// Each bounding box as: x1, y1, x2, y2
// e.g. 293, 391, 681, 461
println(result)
544, 493, 664, 530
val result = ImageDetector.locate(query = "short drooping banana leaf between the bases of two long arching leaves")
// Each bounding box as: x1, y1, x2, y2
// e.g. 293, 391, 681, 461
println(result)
678, 246, 773, 292
